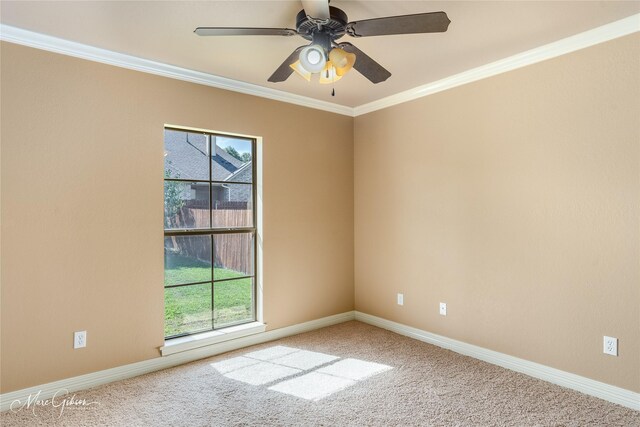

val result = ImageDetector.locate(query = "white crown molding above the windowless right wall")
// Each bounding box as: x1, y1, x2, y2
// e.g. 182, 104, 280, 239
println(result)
354, 14, 640, 117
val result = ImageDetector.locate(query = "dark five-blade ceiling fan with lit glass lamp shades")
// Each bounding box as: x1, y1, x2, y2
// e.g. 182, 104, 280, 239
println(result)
194, 0, 451, 83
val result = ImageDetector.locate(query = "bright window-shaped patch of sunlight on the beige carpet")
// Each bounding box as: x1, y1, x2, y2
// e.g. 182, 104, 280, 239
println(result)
211, 345, 393, 401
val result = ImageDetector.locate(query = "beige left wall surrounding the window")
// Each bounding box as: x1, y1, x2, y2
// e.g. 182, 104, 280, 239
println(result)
0, 43, 354, 393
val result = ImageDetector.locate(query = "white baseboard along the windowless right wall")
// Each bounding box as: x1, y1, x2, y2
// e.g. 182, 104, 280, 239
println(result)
355, 311, 640, 411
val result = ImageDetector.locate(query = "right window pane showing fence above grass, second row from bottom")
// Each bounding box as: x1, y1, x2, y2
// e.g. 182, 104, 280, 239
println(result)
213, 233, 253, 280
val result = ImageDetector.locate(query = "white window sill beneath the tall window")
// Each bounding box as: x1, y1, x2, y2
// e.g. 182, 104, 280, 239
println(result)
160, 322, 267, 356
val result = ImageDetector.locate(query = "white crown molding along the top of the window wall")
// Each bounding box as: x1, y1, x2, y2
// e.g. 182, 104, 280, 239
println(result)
0, 24, 353, 117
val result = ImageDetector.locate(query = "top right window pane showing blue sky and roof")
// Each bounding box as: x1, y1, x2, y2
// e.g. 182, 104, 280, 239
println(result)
211, 136, 253, 182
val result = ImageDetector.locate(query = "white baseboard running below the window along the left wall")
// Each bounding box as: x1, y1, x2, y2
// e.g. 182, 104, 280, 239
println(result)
0, 311, 355, 411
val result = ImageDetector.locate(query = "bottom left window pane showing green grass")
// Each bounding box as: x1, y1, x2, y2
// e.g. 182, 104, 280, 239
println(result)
164, 283, 212, 337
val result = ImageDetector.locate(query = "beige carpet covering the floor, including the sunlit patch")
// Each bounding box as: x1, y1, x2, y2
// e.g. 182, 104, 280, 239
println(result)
0, 322, 640, 427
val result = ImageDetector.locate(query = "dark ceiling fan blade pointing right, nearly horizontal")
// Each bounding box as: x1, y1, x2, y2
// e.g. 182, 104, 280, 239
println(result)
347, 12, 451, 37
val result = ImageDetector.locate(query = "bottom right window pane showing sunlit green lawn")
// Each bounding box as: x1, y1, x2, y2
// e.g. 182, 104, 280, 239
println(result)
213, 278, 253, 328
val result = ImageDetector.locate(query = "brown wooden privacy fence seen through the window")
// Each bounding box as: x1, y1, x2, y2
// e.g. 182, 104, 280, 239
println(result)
165, 207, 254, 275
